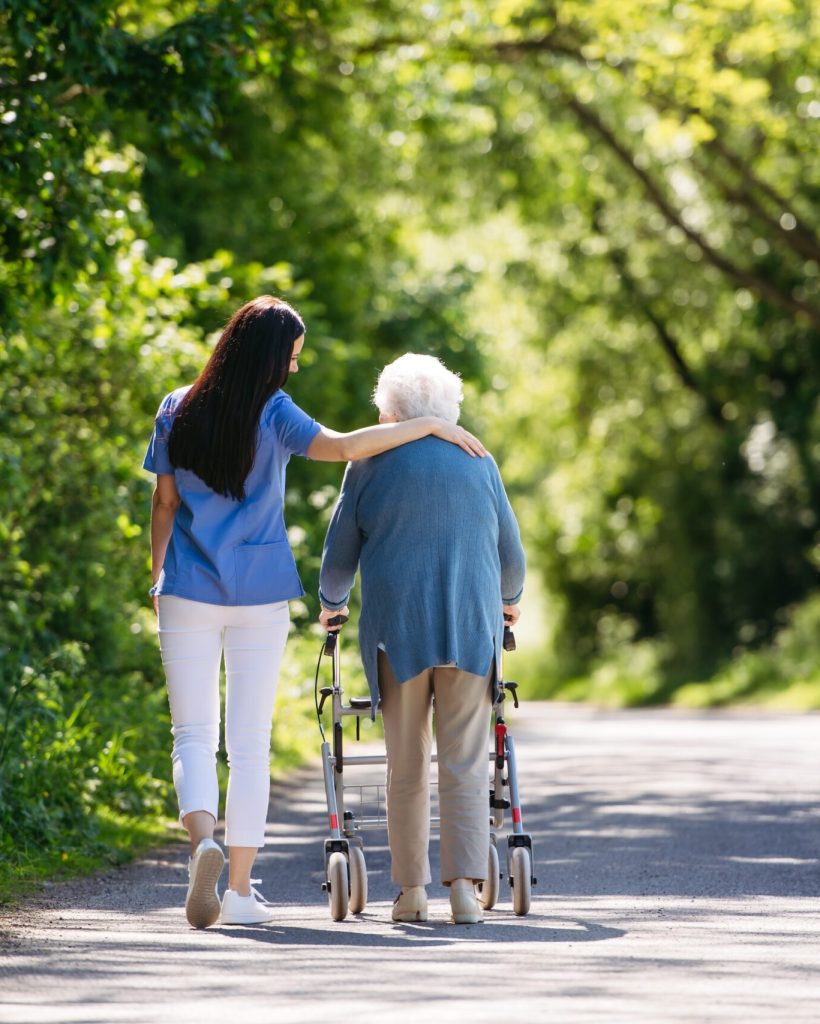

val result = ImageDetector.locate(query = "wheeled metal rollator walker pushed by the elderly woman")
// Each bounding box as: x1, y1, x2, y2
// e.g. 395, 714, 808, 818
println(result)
314, 615, 536, 921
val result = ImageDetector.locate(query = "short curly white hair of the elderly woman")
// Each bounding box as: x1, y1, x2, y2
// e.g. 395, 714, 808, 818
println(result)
373, 352, 464, 423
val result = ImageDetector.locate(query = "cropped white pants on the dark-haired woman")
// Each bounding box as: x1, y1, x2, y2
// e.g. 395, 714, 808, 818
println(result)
160, 597, 290, 847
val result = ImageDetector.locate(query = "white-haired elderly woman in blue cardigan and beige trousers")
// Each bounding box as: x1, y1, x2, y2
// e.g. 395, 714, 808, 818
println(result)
319, 354, 524, 924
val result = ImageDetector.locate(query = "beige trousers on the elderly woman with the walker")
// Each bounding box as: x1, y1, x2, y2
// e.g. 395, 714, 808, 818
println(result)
379, 650, 493, 886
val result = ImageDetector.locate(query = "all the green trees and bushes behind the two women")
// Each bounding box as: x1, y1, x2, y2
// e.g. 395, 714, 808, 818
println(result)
0, 0, 820, 895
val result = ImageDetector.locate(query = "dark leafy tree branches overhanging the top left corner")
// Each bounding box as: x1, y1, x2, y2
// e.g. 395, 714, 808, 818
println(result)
0, 0, 313, 316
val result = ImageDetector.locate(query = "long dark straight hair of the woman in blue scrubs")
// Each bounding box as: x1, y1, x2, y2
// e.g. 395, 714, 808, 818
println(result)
168, 295, 305, 501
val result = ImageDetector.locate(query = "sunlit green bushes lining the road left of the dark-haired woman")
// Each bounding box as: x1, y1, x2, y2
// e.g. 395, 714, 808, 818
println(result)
0, 172, 333, 892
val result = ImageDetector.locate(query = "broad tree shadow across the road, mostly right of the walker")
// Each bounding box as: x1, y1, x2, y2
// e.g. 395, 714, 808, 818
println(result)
261, 727, 820, 902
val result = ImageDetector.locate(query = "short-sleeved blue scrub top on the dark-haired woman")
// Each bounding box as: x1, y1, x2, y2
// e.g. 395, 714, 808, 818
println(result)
142, 386, 321, 605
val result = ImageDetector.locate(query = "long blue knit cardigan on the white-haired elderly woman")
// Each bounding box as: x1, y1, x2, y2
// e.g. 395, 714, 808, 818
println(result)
319, 437, 525, 701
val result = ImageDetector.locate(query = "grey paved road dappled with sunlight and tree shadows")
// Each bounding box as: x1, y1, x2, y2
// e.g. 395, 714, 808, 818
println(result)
0, 705, 820, 1024
